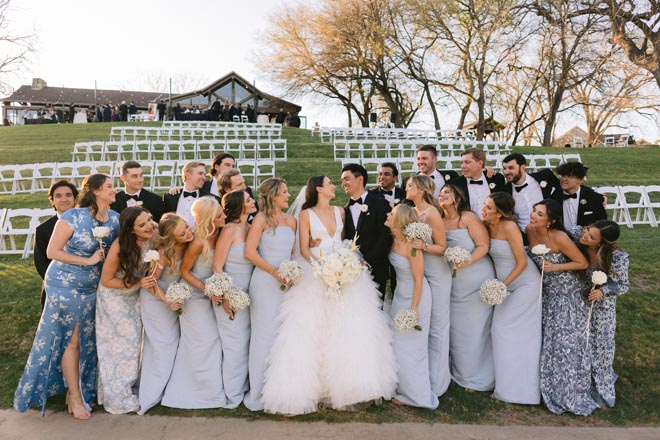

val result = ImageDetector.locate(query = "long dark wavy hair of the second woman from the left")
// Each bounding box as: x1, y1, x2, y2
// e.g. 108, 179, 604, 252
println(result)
117, 206, 149, 287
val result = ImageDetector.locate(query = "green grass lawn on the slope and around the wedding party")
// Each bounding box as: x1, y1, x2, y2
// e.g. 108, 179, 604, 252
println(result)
0, 123, 660, 426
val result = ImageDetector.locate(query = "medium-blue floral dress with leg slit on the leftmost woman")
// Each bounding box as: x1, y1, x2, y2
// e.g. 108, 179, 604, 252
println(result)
14, 208, 119, 415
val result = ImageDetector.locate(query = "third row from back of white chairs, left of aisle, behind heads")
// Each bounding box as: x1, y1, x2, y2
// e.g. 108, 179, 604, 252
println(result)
0, 159, 275, 194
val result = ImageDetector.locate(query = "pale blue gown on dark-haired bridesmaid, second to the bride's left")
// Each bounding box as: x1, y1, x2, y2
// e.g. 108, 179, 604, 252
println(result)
213, 242, 254, 409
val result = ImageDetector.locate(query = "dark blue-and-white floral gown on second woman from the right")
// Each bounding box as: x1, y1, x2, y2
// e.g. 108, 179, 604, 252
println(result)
529, 252, 598, 416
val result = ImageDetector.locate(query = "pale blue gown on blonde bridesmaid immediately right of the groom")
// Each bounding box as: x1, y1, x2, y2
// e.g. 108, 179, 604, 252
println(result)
389, 252, 438, 409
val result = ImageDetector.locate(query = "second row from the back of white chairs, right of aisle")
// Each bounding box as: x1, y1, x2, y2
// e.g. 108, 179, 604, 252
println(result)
333, 140, 511, 160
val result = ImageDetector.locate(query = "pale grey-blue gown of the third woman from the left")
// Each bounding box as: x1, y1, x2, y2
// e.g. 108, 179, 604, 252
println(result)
138, 260, 181, 415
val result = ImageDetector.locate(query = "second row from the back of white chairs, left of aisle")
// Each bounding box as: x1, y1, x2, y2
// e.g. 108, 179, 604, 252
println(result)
71, 138, 287, 162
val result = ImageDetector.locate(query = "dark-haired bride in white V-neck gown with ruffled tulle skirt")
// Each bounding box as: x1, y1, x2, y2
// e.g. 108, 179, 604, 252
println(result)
263, 176, 397, 415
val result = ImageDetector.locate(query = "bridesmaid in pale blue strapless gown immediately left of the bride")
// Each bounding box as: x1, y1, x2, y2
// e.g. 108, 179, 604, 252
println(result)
243, 178, 297, 411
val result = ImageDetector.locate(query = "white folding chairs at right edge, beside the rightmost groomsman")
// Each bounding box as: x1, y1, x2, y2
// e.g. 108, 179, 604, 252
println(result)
594, 185, 660, 228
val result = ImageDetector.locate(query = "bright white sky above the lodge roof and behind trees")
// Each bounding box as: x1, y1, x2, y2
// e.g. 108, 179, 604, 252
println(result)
10, 0, 660, 140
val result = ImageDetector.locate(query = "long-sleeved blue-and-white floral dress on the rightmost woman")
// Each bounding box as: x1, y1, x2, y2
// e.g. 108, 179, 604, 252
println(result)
585, 250, 629, 408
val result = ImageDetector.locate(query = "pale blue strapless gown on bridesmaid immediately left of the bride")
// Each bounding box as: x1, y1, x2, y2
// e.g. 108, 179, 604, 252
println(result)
243, 226, 296, 411
